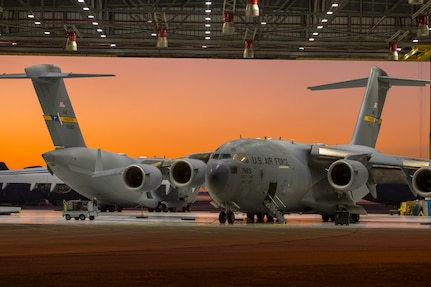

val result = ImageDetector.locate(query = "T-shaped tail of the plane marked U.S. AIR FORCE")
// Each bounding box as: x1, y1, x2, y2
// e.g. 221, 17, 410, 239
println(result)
309, 67, 431, 148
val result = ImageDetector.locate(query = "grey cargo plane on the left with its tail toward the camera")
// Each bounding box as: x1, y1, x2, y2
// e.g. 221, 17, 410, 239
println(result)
0, 64, 209, 214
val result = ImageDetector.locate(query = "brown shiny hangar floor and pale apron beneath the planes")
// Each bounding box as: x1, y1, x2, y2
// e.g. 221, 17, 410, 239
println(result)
0, 210, 431, 287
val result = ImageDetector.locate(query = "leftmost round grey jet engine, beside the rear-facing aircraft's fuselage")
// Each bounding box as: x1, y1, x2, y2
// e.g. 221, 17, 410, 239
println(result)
123, 164, 163, 191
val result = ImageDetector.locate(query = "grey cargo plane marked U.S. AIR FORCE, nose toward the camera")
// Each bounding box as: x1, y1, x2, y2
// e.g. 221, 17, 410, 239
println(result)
170, 67, 431, 223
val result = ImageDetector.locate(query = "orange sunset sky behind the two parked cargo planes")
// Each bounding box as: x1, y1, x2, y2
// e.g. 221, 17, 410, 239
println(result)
0, 56, 430, 169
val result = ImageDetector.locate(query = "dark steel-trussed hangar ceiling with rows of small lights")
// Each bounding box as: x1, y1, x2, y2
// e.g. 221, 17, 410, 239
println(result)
0, 0, 431, 60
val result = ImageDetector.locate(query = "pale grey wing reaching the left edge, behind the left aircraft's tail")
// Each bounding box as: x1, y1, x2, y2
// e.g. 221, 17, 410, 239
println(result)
0, 167, 64, 194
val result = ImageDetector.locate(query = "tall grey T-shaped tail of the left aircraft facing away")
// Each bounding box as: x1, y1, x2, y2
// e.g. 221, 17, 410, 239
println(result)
0, 64, 113, 147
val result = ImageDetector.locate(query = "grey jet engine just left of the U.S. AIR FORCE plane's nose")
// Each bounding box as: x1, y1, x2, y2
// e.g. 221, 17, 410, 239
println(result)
169, 158, 206, 187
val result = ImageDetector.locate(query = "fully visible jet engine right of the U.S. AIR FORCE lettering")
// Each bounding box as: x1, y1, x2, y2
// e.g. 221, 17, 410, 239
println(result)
328, 159, 368, 191
